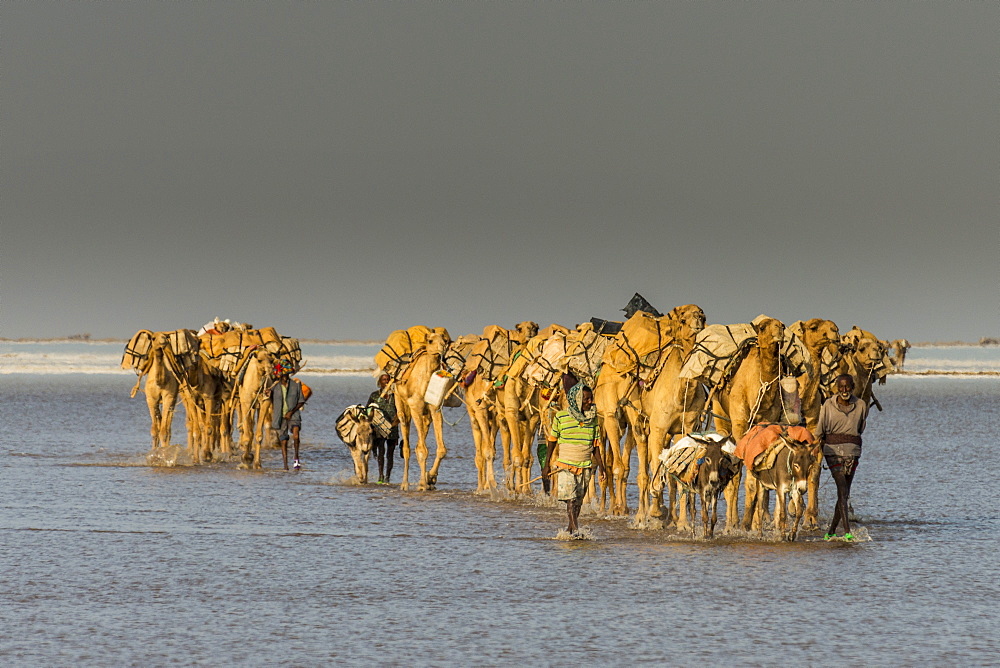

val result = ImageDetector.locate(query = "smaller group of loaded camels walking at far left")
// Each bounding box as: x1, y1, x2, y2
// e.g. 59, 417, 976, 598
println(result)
121, 319, 302, 469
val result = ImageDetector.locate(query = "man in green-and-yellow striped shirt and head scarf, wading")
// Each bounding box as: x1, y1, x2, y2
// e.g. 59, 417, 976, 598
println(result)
542, 383, 607, 538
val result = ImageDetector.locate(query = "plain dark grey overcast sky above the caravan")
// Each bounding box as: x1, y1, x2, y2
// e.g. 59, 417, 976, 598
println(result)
0, 1, 1000, 341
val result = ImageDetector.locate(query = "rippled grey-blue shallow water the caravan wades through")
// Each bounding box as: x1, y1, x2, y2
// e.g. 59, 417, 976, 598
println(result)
0, 374, 1000, 665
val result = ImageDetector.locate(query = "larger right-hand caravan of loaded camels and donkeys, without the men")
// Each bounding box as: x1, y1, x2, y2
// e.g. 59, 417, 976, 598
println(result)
368, 294, 902, 540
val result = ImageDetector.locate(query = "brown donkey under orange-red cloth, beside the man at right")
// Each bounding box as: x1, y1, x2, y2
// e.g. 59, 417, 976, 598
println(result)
744, 434, 821, 541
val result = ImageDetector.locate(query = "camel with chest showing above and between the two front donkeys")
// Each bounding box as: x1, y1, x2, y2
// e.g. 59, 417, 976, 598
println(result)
712, 316, 785, 530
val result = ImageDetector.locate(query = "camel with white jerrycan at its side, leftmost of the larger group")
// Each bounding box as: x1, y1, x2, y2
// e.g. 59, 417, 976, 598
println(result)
393, 327, 451, 491
